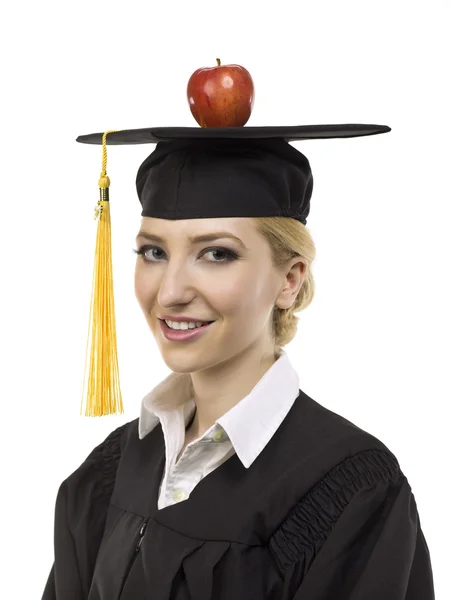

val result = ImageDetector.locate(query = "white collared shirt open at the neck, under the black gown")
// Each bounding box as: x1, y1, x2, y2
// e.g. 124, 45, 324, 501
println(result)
139, 349, 299, 509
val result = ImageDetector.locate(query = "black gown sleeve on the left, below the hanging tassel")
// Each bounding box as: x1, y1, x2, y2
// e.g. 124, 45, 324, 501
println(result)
42, 424, 126, 600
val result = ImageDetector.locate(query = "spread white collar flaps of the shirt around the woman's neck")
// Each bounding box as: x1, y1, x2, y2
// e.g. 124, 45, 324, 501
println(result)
139, 349, 299, 468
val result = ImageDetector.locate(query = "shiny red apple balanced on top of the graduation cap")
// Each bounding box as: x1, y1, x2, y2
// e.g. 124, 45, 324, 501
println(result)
187, 58, 254, 127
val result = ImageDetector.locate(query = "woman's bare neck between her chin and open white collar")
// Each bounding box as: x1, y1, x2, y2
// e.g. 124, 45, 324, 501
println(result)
188, 346, 280, 438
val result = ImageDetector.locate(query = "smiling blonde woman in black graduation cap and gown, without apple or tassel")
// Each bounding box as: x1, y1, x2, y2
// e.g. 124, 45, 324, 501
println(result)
43, 125, 434, 600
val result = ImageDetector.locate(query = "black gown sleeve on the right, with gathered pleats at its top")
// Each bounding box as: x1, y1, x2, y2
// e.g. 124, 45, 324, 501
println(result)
270, 450, 435, 600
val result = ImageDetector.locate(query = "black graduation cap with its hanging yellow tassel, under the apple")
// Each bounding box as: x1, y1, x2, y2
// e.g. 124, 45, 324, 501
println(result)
76, 124, 391, 416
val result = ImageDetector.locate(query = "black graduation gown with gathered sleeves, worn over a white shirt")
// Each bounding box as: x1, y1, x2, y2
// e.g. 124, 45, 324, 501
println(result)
42, 390, 435, 600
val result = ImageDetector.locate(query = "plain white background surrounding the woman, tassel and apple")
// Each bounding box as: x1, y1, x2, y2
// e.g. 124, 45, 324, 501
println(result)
0, 0, 449, 600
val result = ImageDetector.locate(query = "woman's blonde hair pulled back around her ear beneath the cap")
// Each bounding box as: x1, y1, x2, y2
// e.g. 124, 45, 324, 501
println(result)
251, 217, 316, 354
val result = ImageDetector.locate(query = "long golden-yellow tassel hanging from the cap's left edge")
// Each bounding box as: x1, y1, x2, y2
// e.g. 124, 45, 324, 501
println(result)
81, 129, 124, 417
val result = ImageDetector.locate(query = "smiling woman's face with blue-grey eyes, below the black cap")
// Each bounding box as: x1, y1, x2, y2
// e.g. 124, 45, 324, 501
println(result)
135, 217, 295, 373
